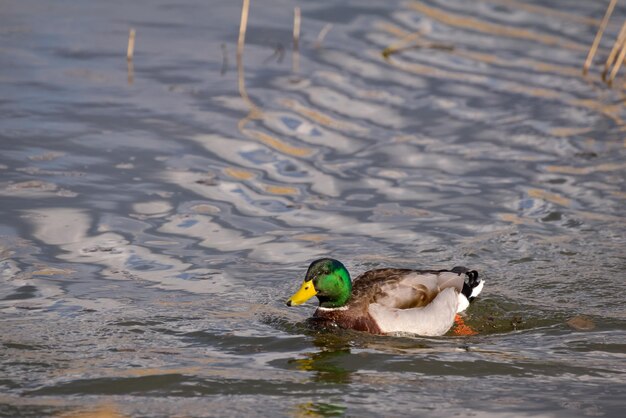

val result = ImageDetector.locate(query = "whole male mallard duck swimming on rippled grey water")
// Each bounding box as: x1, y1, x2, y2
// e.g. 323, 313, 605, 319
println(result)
287, 258, 484, 335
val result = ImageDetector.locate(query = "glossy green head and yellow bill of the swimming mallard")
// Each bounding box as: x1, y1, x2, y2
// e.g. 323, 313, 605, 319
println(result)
287, 258, 352, 308
